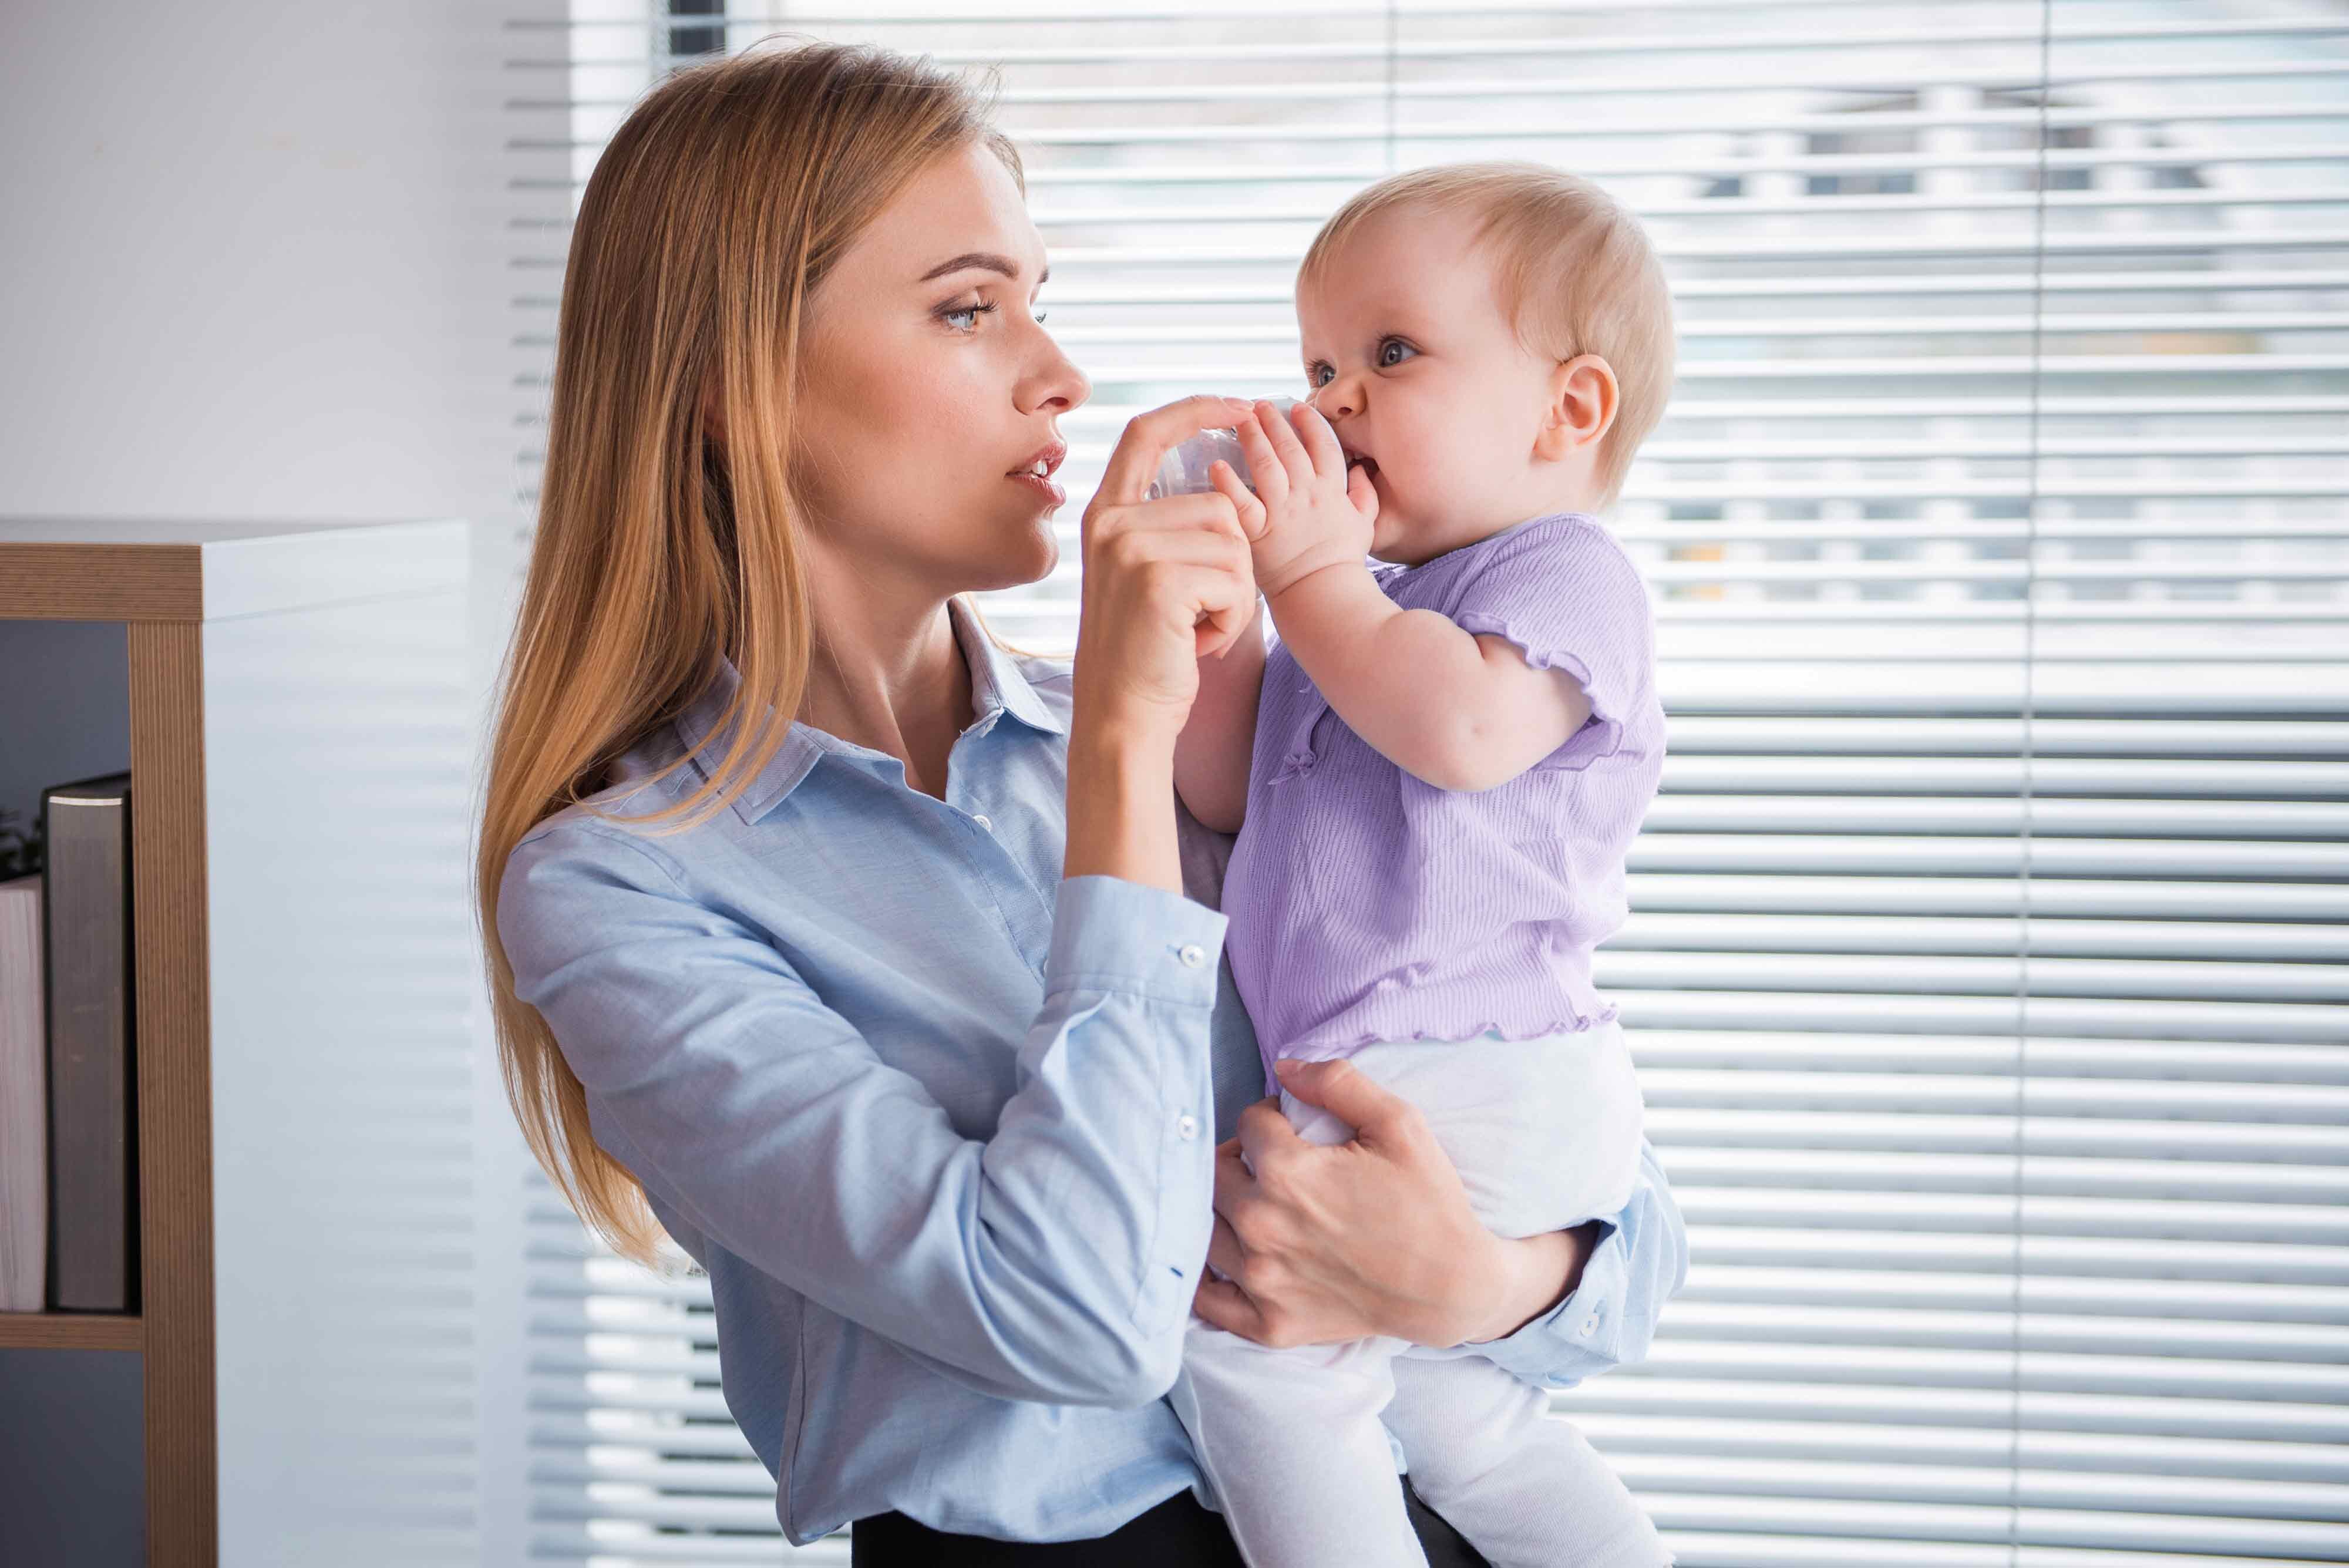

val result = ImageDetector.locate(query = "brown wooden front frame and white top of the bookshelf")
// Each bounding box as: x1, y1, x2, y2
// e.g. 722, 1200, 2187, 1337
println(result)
0, 519, 465, 1568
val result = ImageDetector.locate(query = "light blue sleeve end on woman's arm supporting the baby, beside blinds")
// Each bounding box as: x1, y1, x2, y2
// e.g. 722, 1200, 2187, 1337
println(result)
1419, 1139, 1689, 1387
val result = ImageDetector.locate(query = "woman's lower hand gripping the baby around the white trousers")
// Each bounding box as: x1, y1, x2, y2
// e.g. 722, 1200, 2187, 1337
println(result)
1193, 1061, 1588, 1347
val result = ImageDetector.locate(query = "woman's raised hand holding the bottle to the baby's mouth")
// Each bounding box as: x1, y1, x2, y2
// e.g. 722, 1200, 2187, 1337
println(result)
1071, 394, 1257, 744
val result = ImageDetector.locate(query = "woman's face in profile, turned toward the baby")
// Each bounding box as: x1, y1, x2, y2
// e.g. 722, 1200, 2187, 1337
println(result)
794, 143, 1092, 596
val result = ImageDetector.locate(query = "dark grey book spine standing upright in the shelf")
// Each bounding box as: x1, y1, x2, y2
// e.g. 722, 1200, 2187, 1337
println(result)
40, 772, 139, 1312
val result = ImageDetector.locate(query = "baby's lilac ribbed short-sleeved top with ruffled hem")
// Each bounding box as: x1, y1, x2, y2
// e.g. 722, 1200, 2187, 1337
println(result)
1224, 512, 1663, 1082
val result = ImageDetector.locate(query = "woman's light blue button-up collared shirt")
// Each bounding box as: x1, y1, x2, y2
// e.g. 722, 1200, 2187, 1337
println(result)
498, 598, 1687, 1545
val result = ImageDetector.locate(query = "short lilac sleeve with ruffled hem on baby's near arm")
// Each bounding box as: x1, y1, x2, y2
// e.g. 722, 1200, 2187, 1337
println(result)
1452, 519, 1656, 768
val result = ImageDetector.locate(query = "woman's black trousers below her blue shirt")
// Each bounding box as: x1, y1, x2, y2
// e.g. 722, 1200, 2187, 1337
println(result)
848, 1476, 1492, 1568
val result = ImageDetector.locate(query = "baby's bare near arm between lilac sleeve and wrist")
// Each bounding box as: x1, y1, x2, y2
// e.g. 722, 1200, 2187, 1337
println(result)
1268, 563, 1590, 788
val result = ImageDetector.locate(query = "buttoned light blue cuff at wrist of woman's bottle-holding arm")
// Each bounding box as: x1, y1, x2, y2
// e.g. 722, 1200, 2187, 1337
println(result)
1043, 876, 1231, 1007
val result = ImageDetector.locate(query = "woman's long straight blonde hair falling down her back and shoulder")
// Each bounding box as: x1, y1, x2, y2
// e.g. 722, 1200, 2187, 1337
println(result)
474, 38, 1027, 1267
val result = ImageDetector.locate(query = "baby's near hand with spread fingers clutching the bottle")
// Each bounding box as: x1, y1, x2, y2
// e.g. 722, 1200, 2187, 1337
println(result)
1212, 401, 1379, 598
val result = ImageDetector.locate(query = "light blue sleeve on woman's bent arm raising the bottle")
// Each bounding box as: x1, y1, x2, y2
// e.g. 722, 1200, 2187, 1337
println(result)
498, 824, 1226, 1406
